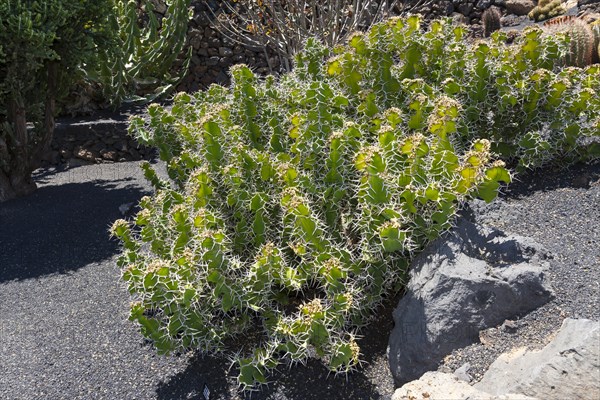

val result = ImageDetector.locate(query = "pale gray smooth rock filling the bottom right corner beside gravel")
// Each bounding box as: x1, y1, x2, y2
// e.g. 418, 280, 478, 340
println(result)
475, 319, 600, 400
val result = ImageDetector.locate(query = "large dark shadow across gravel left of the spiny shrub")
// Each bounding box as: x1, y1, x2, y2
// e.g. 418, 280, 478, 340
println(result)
0, 177, 147, 283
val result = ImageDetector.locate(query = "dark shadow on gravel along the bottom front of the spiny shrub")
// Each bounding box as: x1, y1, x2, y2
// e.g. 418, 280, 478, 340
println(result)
156, 296, 400, 400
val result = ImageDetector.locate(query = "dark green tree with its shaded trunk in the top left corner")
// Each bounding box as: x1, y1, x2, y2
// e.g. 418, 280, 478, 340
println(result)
0, 0, 112, 202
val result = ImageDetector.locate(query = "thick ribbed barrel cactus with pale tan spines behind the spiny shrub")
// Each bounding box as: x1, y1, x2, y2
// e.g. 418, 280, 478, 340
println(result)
543, 16, 597, 67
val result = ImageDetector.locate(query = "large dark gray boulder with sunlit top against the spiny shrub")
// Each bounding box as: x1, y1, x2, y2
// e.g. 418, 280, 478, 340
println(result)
388, 218, 553, 386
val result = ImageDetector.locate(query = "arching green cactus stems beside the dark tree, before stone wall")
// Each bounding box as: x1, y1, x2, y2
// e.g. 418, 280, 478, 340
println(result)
91, 0, 193, 105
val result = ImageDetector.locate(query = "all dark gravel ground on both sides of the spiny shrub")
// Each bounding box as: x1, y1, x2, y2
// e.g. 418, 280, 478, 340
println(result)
0, 158, 600, 399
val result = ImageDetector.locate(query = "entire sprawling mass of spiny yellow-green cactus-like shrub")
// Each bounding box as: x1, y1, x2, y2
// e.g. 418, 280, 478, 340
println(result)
112, 17, 600, 389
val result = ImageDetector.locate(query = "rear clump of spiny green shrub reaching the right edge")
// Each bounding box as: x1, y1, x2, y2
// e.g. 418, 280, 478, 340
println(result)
328, 17, 600, 170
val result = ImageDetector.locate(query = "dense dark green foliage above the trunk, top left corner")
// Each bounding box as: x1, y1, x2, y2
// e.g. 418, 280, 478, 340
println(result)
0, 0, 113, 104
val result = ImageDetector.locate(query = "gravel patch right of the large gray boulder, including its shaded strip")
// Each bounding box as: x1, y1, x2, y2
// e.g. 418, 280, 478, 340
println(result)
439, 163, 600, 380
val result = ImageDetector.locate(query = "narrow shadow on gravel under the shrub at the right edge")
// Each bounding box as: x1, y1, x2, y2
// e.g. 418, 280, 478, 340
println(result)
504, 162, 600, 198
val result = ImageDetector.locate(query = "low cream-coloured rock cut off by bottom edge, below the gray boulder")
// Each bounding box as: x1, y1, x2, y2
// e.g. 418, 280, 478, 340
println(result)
392, 372, 535, 400
